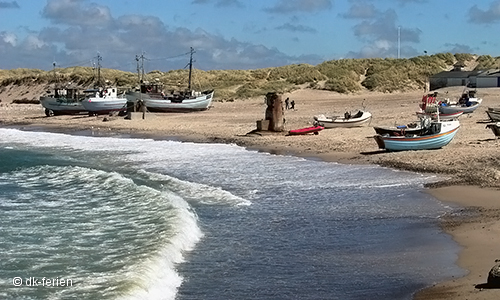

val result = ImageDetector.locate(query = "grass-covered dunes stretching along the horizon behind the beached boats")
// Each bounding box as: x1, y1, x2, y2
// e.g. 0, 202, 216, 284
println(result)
0, 53, 500, 101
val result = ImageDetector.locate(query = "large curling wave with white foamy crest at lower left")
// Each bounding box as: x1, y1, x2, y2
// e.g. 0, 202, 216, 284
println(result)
0, 165, 203, 299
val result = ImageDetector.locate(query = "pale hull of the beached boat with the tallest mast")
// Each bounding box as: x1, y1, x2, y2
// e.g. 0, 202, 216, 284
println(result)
126, 91, 214, 112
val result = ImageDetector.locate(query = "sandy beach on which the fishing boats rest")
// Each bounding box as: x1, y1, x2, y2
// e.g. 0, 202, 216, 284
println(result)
0, 87, 500, 299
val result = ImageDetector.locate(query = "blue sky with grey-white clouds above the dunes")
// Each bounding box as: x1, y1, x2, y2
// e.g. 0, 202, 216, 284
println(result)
0, 0, 500, 72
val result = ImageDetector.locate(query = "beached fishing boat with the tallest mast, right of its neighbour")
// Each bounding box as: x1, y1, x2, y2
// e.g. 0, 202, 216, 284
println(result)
126, 48, 214, 112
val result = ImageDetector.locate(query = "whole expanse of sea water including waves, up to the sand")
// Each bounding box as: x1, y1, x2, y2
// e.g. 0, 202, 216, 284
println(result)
0, 128, 463, 300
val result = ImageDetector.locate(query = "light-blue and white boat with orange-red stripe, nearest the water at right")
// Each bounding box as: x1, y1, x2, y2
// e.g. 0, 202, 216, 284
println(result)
374, 119, 460, 151
